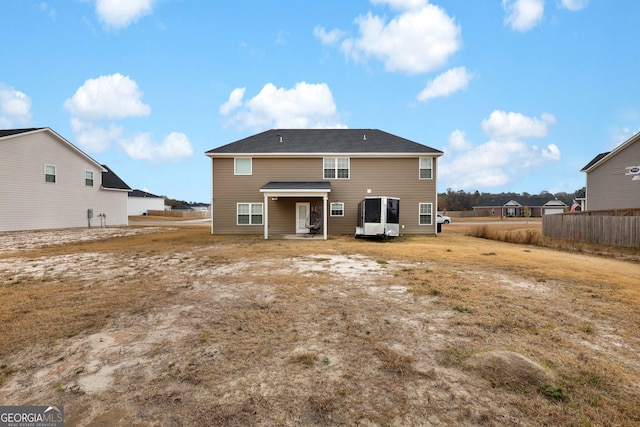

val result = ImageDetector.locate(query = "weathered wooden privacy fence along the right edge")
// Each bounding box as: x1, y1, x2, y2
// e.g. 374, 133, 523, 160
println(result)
542, 209, 640, 247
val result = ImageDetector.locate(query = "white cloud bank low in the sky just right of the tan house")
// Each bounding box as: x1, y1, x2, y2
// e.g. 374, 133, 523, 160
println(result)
438, 111, 561, 190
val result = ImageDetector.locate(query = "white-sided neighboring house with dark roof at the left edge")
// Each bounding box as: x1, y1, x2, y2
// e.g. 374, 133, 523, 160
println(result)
0, 128, 131, 232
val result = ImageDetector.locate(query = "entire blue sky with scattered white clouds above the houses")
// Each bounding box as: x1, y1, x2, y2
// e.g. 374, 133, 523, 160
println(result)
0, 0, 640, 202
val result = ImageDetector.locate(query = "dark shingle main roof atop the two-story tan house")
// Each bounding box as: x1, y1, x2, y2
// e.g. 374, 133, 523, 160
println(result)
206, 129, 442, 155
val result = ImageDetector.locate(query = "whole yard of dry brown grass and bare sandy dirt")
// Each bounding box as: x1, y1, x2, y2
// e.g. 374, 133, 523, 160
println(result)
0, 226, 640, 426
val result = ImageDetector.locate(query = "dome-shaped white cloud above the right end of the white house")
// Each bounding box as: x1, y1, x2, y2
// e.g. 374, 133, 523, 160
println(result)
64, 73, 151, 120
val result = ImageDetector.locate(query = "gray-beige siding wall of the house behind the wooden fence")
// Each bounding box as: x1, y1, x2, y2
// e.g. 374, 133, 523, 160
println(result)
587, 140, 640, 210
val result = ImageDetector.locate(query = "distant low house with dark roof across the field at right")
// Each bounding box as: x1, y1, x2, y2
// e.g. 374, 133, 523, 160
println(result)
473, 196, 568, 218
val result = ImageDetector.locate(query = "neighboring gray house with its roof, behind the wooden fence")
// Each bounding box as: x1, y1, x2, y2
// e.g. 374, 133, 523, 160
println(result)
581, 133, 640, 211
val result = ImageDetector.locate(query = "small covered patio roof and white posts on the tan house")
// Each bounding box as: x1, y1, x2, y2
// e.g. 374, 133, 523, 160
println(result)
260, 181, 331, 240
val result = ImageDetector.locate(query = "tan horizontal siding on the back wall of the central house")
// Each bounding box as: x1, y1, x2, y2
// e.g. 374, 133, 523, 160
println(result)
212, 156, 437, 234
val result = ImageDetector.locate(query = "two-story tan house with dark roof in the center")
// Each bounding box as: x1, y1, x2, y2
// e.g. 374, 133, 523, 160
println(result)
205, 129, 443, 239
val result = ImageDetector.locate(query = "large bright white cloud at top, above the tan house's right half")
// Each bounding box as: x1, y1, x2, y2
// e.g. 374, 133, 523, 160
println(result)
341, 0, 462, 74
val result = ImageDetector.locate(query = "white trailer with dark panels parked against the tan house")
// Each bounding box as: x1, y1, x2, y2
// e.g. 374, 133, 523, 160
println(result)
355, 196, 400, 238
